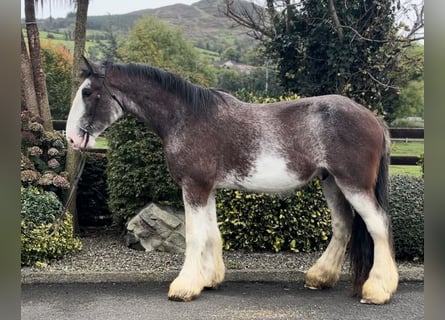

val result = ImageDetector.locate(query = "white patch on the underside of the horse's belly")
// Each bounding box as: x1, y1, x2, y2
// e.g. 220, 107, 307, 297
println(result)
218, 154, 306, 192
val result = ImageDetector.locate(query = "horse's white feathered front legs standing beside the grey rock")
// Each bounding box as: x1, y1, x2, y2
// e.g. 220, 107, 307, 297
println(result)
168, 190, 225, 301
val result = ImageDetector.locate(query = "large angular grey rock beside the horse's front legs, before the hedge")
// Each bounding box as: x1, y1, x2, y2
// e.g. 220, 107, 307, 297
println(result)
125, 203, 185, 253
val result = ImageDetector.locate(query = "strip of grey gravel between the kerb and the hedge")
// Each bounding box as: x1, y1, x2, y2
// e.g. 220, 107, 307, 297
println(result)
22, 230, 423, 280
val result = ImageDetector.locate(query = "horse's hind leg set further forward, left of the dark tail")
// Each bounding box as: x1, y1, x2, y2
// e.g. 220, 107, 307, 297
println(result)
305, 175, 353, 289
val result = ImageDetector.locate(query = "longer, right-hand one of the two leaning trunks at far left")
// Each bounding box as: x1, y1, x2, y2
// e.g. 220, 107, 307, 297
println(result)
25, 0, 53, 131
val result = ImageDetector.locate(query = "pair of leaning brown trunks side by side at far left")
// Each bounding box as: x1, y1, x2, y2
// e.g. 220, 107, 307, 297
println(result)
21, 0, 53, 130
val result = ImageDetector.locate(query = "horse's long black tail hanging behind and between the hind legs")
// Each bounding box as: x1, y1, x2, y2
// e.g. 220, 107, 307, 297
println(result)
350, 121, 393, 296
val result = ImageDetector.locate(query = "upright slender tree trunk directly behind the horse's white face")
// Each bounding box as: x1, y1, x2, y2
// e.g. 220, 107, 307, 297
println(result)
66, 0, 89, 232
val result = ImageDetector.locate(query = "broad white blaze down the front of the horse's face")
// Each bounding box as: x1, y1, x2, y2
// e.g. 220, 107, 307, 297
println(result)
66, 79, 91, 146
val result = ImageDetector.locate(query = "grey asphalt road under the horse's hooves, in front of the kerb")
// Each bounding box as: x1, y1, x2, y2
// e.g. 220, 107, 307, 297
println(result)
21, 282, 424, 320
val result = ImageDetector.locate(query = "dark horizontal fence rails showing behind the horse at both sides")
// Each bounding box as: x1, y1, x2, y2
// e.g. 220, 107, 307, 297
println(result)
53, 120, 424, 166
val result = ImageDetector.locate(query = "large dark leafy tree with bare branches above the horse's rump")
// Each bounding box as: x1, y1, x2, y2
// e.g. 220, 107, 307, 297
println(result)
225, 0, 423, 120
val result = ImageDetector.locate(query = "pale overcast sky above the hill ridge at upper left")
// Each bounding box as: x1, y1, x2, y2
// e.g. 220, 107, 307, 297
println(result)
21, 0, 199, 19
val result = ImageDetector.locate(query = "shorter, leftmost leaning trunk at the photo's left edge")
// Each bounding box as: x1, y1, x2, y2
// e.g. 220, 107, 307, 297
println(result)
20, 32, 40, 116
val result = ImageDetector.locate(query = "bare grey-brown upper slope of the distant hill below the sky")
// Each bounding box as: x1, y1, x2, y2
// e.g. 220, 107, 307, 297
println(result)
39, 0, 260, 52
